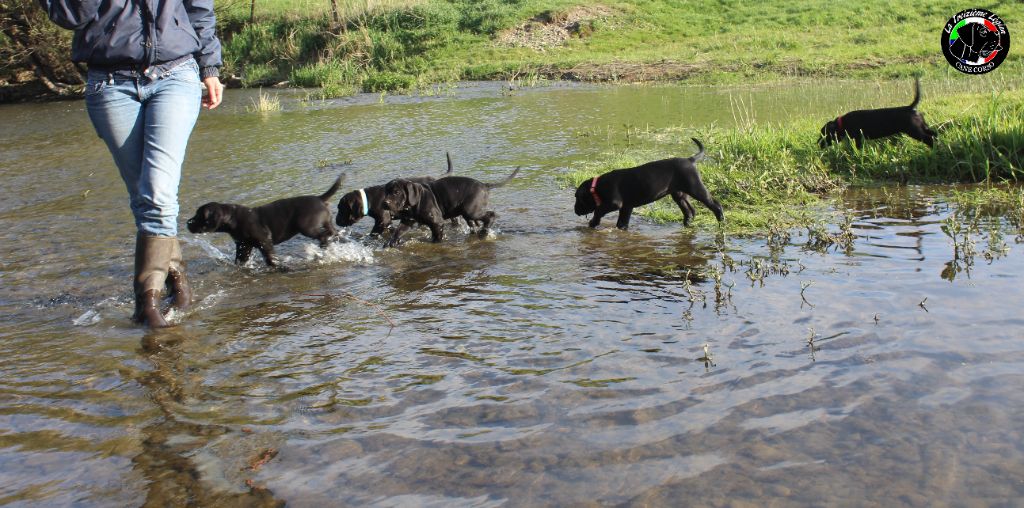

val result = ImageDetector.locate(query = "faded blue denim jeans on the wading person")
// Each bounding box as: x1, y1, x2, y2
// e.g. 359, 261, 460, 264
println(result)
85, 60, 203, 237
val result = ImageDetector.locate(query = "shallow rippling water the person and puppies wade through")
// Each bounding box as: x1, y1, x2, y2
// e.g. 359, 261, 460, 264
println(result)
0, 83, 1024, 506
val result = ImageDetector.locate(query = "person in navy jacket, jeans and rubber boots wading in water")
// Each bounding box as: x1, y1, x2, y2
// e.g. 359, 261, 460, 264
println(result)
38, 0, 223, 328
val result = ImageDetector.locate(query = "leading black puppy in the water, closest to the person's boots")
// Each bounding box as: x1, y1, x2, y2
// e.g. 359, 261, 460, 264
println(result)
186, 176, 342, 266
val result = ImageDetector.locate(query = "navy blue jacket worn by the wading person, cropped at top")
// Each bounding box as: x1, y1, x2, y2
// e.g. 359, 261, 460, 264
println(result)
39, 0, 221, 78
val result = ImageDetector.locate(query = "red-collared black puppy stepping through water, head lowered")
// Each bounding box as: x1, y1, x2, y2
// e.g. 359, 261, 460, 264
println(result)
574, 138, 724, 229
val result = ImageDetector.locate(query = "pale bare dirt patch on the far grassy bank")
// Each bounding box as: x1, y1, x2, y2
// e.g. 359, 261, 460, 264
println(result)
497, 5, 614, 51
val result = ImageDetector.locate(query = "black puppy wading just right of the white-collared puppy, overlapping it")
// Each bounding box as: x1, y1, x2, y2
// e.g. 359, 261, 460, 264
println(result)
384, 168, 519, 247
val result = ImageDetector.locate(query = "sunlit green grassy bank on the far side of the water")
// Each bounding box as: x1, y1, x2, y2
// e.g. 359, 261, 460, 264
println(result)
211, 0, 1024, 94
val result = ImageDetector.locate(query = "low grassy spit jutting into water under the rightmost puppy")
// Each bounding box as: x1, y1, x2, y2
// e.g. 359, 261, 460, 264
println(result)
561, 90, 1024, 232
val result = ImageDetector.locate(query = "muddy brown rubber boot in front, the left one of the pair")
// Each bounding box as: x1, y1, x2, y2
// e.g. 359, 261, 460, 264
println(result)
132, 232, 177, 328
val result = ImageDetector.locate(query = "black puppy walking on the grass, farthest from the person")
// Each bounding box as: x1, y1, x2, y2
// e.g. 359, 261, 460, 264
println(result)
818, 80, 938, 149
